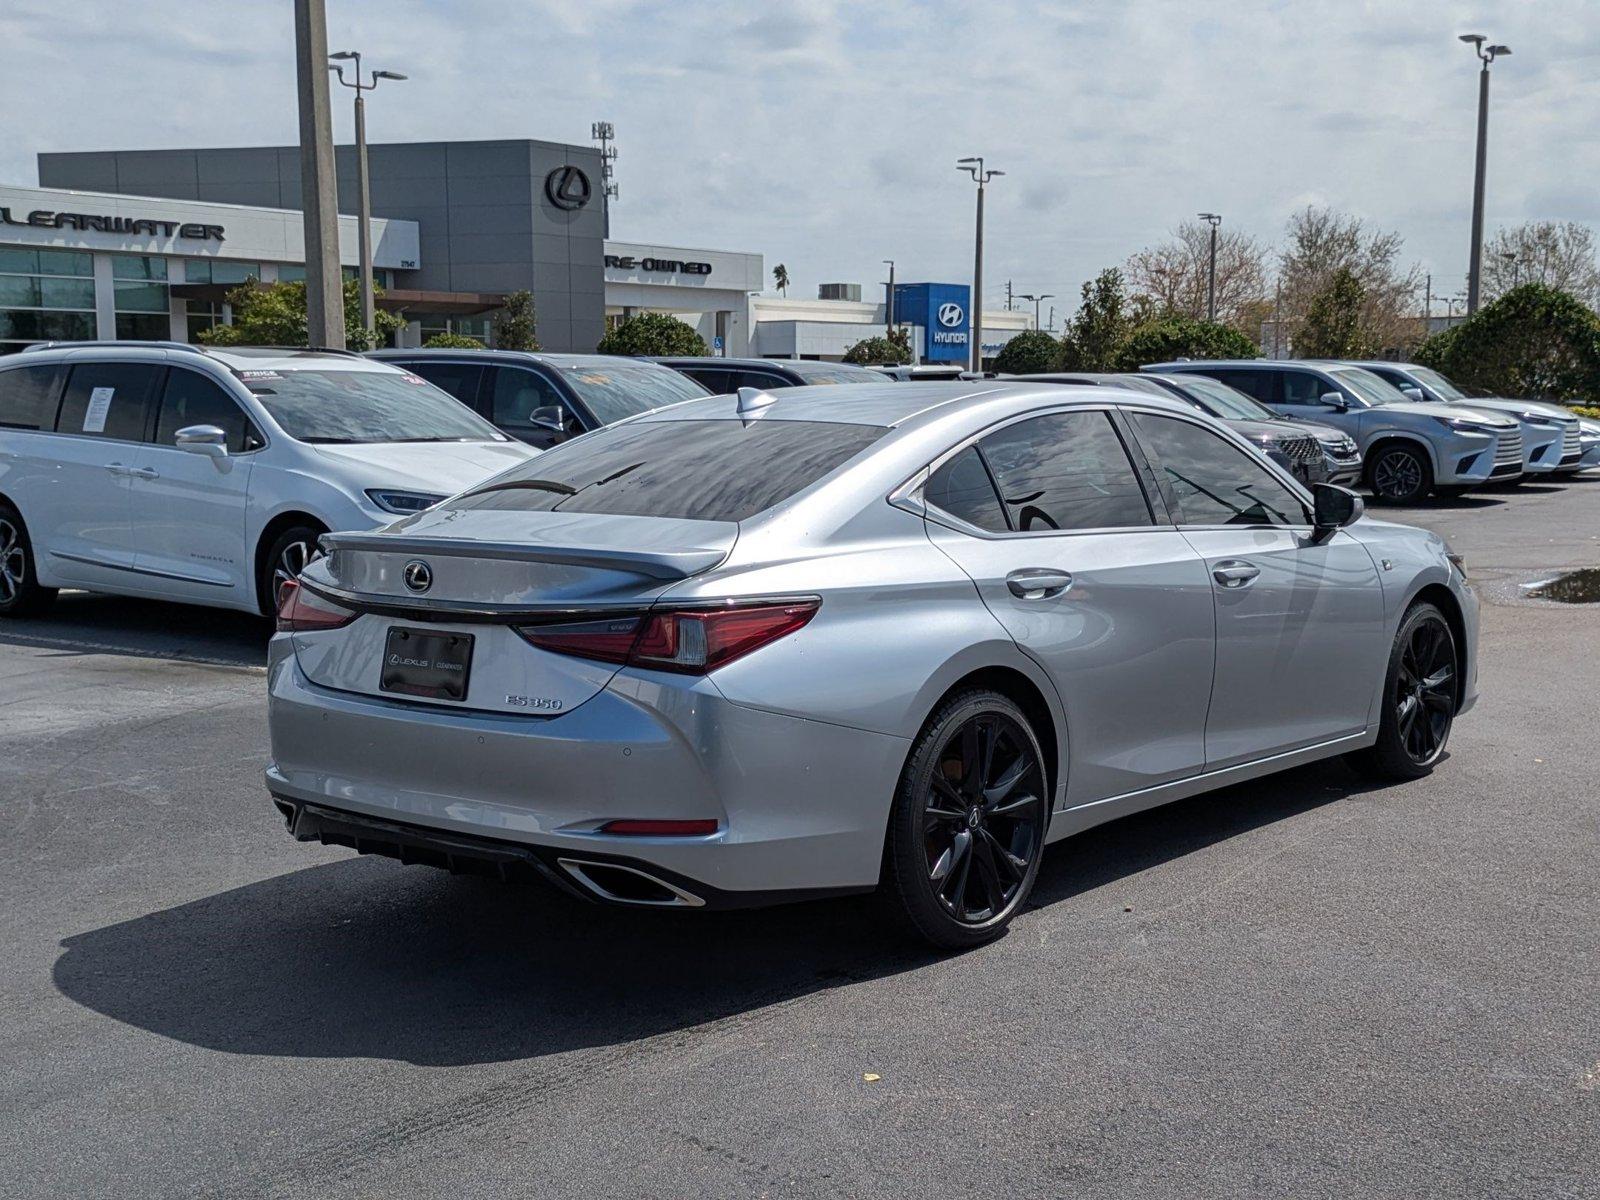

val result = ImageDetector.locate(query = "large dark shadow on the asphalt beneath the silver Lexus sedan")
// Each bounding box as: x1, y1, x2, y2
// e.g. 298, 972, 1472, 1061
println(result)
54, 763, 1388, 1066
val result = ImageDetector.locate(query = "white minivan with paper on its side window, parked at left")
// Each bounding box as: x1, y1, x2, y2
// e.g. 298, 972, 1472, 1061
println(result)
0, 342, 538, 616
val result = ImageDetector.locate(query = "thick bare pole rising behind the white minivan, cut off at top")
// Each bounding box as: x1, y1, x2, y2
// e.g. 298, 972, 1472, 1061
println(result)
294, 0, 344, 350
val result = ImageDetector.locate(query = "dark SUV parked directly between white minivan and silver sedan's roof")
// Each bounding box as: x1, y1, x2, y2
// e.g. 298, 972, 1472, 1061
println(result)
370, 350, 706, 450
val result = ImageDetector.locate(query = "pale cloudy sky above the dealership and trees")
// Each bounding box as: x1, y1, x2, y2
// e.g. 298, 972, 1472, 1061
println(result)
0, 0, 1600, 321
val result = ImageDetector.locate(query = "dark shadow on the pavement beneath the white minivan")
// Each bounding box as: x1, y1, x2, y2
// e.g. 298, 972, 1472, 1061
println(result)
0, 592, 272, 667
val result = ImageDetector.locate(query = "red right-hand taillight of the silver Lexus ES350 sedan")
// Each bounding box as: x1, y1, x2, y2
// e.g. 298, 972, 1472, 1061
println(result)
517, 600, 822, 675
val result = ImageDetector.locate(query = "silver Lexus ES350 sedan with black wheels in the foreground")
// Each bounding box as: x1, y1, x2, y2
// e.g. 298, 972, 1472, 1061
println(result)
267, 381, 1477, 947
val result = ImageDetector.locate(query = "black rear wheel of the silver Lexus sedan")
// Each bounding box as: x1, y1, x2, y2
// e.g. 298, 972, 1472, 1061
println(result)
882, 688, 1050, 950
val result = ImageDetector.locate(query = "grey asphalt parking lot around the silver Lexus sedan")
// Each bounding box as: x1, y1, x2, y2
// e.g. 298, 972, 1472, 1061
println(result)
0, 480, 1600, 1197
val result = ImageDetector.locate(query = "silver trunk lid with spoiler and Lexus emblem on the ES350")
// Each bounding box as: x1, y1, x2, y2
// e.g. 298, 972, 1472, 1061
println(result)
293, 509, 739, 717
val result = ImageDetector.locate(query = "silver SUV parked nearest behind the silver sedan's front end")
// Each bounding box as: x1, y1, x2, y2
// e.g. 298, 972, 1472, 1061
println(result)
1141, 358, 1523, 504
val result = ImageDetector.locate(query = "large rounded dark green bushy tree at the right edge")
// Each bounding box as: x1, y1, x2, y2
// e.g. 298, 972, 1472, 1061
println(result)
1416, 283, 1600, 402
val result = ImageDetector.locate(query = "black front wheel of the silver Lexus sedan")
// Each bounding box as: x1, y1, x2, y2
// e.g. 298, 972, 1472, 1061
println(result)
1349, 603, 1461, 781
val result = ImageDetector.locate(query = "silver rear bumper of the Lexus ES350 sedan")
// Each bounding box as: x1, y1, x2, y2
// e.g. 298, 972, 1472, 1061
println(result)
266, 638, 909, 904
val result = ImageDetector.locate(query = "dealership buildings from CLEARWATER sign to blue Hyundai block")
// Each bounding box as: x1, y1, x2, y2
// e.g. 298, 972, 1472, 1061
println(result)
0, 139, 1032, 362
